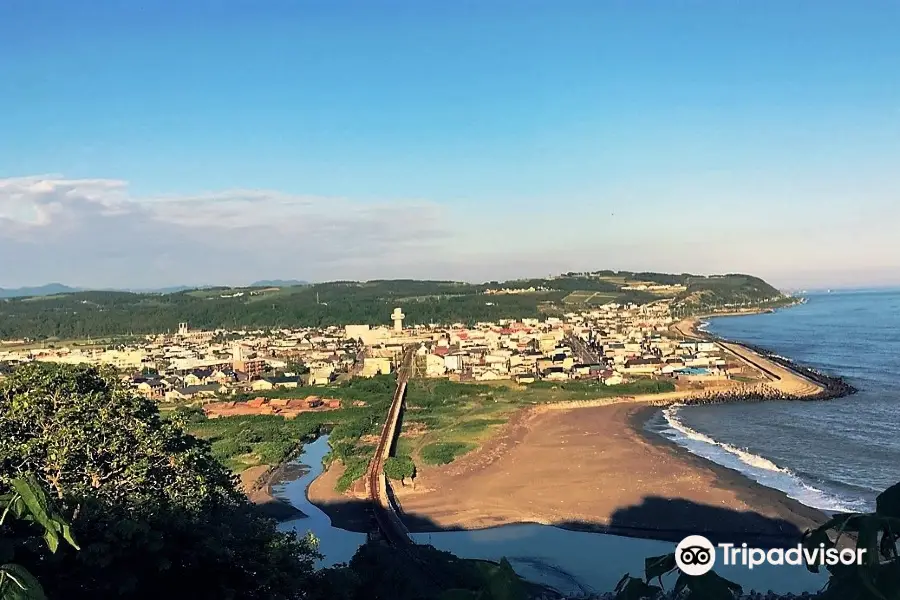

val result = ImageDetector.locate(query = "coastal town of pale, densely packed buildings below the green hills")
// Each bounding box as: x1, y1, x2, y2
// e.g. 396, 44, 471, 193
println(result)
0, 303, 788, 416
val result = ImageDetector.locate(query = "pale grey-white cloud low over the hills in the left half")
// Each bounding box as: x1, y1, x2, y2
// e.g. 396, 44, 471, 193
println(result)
0, 175, 446, 287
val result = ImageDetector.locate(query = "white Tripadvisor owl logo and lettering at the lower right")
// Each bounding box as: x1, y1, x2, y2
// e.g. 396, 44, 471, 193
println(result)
675, 535, 866, 575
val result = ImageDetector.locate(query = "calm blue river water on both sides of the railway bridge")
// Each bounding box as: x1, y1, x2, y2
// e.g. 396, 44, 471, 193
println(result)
272, 435, 825, 594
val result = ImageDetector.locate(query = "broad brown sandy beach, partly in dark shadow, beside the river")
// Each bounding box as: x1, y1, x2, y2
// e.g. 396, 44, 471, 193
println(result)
310, 402, 826, 545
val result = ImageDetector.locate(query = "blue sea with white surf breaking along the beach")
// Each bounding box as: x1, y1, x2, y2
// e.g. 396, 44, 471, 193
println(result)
648, 290, 900, 512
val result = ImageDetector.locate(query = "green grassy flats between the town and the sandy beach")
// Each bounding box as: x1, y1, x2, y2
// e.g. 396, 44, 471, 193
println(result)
183, 375, 672, 492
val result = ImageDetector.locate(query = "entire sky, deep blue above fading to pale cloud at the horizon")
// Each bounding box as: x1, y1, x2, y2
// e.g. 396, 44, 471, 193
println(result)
0, 0, 900, 287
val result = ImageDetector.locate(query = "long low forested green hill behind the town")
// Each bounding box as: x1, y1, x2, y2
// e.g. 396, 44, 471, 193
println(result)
0, 271, 781, 339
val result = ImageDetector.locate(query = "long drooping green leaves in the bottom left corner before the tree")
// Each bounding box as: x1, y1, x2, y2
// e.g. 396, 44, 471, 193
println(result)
0, 475, 80, 600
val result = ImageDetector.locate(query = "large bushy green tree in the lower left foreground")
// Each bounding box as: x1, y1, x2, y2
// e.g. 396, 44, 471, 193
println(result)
0, 363, 318, 599
